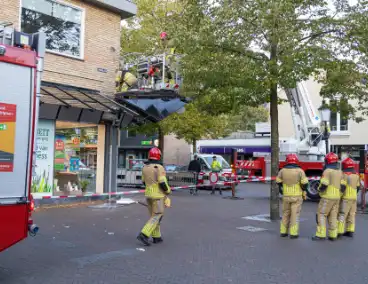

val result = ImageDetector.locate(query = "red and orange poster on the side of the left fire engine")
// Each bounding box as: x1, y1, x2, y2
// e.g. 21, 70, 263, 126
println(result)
0, 103, 17, 172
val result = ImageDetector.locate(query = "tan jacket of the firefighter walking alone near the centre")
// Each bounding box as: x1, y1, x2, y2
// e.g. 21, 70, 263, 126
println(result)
142, 163, 171, 199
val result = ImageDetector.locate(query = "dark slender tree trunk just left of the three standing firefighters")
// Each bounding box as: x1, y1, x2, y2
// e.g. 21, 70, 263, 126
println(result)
270, 43, 280, 220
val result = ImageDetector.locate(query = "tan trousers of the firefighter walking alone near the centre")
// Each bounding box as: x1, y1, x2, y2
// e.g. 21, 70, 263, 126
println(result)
141, 198, 165, 238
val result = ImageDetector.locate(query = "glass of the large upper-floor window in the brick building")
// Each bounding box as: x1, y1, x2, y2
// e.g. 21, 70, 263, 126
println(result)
21, 0, 84, 58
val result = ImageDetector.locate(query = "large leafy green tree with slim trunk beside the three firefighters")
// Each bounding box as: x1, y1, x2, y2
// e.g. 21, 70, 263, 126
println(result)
175, 0, 368, 220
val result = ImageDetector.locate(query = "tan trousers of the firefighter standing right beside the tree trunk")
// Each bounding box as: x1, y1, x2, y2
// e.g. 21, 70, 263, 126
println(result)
280, 196, 303, 236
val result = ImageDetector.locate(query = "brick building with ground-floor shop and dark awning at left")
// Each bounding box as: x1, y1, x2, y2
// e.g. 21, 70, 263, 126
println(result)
0, 0, 137, 197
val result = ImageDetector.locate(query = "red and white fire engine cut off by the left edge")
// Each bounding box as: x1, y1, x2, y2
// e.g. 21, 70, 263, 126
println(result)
0, 21, 46, 251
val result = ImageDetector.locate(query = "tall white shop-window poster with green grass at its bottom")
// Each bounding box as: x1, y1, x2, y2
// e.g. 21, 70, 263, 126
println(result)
32, 120, 55, 193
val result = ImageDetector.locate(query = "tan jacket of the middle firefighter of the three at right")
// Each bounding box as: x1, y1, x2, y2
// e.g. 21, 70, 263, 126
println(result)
318, 168, 346, 199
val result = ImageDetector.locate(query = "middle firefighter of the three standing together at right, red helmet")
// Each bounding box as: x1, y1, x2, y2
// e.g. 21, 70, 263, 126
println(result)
312, 153, 346, 241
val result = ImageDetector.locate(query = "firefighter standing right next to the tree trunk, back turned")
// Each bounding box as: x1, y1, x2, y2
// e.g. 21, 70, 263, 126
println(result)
276, 154, 309, 239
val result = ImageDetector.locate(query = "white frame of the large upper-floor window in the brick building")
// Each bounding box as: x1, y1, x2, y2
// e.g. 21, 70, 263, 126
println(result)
19, 0, 86, 61
